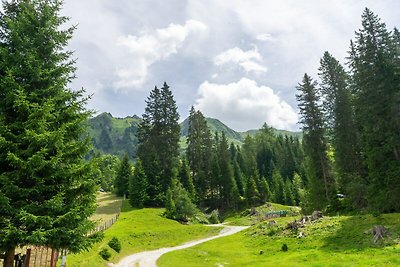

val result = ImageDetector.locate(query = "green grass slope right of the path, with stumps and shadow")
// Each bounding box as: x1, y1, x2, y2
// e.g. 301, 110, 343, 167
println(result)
158, 214, 400, 267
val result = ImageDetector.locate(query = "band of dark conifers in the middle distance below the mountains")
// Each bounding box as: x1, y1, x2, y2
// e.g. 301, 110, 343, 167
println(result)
115, 83, 305, 218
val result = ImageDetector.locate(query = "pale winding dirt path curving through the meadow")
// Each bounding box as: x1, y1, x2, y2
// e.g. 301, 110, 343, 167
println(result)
109, 224, 248, 267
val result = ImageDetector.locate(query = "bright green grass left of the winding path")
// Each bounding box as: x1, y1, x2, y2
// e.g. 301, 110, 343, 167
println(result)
67, 201, 220, 267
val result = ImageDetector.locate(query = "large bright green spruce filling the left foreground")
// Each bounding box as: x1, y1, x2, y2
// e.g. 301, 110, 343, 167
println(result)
0, 0, 96, 267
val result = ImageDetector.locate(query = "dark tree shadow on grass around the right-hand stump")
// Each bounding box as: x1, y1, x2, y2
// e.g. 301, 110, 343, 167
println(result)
321, 214, 400, 252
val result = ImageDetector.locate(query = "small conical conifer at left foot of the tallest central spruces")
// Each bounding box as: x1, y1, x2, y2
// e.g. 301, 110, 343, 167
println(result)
129, 159, 148, 208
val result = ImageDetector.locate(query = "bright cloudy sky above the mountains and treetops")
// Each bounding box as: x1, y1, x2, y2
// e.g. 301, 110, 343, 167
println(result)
63, 0, 400, 131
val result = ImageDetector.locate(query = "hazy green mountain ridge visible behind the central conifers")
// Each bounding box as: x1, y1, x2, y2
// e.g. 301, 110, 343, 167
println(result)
88, 113, 302, 159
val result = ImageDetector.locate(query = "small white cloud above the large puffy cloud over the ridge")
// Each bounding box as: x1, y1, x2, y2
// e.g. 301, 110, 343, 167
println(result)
214, 47, 267, 73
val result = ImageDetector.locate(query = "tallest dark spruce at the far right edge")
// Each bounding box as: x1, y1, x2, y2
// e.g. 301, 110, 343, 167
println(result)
349, 8, 400, 212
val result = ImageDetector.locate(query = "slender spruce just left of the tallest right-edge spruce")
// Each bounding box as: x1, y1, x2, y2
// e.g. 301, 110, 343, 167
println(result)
319, 52, 366, 208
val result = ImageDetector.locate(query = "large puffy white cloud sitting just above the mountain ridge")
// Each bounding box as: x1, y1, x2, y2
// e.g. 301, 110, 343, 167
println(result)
195, 78, 298, 131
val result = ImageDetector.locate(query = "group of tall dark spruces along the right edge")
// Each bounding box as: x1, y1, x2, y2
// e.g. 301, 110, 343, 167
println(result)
297, 8, 400, 214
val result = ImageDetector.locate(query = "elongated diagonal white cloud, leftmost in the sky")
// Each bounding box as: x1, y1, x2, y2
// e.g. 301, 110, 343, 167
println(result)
114, 20, 207, 88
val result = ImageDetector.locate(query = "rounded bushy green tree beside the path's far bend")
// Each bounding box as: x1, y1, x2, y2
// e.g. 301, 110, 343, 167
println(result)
165, 179, 198, 221
